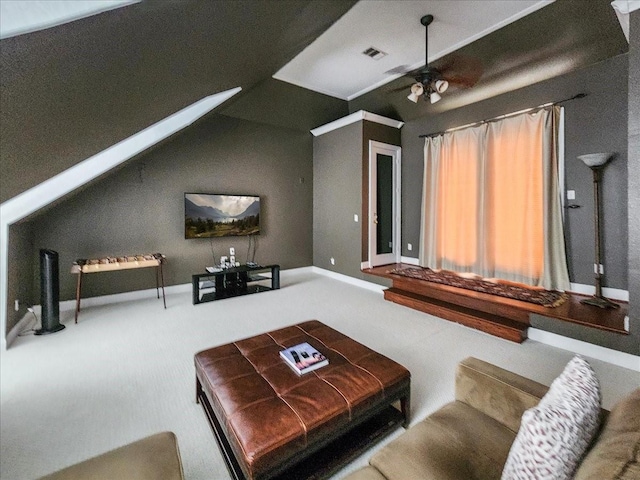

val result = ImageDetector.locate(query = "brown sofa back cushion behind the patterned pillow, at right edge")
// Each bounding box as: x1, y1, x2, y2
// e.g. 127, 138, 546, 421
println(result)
575, 388, 640, 480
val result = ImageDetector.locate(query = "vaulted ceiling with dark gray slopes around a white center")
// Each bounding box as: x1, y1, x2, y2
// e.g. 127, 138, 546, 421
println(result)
0, 0, 628, 202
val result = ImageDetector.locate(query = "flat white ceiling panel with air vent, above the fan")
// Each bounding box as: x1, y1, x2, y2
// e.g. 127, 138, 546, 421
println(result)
273, 0, 555, 100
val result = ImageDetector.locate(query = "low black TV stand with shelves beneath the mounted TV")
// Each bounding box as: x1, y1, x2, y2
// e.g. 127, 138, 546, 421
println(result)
191, 265, 280, 305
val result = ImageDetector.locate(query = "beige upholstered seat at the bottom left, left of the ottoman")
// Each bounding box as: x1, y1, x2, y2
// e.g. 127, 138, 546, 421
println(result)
41, 432, 184, 480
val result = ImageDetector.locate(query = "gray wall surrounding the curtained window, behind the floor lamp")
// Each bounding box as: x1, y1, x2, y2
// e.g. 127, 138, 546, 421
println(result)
402, 54, 628, 290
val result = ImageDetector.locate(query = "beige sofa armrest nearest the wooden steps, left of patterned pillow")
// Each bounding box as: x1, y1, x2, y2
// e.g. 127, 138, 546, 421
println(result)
456, 357, 549, 433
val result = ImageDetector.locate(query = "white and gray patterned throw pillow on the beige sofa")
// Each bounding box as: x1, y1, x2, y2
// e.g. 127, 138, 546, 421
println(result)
502, 355, 601, 480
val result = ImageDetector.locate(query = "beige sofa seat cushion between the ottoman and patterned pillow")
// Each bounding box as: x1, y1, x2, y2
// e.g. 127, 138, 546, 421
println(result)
369, 401, 515, 480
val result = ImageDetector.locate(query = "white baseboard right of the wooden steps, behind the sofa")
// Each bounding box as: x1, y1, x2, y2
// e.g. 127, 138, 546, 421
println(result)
528, 327, 640, 372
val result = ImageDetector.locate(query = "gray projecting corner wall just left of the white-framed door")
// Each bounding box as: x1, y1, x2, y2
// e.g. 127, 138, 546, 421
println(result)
313, 120, 400, 283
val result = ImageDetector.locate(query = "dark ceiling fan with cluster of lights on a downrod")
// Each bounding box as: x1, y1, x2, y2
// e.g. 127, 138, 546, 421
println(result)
398, 15, 482, 103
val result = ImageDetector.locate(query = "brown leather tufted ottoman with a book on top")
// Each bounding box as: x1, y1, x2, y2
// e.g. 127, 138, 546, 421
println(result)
195, 320, 411, 479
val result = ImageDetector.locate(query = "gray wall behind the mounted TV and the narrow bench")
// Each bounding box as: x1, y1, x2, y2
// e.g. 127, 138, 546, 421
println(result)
13, 115, 313, 310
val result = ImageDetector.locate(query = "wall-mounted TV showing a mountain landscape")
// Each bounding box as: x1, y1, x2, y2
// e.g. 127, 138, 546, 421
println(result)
184, 194, 260, 238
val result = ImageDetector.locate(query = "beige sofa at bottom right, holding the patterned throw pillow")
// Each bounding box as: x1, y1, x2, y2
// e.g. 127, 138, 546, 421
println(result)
345, 358, 640, 480
